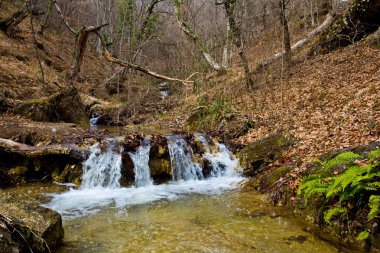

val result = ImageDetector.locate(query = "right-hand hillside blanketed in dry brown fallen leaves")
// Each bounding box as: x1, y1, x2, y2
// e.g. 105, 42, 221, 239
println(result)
236, 41, 380, 160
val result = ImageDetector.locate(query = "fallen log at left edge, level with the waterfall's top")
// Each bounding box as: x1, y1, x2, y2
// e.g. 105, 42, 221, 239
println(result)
0, 138, 86, 160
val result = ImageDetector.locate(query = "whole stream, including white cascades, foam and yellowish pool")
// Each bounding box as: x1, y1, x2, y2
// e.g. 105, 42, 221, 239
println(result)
3, 136, 341, 253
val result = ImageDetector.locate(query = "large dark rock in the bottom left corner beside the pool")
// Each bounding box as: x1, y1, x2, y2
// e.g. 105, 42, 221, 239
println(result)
0, 195, 64, 252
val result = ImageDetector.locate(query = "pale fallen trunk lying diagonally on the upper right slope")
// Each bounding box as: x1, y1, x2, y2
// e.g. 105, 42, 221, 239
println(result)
253, 13, 334, 73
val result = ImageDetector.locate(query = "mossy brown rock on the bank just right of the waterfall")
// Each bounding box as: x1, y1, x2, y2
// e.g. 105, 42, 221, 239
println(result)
239, 134, 293, 177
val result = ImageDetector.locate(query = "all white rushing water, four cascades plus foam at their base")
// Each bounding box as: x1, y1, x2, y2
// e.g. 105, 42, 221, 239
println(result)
45, 136, 243, 220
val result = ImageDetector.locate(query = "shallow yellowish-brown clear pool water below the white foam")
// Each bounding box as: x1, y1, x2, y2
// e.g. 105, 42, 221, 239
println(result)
0, 185, 340, 253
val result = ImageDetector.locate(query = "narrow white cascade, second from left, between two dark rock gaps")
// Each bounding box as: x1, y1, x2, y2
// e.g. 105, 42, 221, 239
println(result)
128, 139, 153, 187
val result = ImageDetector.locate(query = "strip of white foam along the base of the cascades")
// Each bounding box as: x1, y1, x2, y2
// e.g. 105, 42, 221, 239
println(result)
44, 177, 244, 220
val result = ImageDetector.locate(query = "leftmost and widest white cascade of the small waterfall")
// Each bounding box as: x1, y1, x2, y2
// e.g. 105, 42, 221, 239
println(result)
81, 140, 122, 189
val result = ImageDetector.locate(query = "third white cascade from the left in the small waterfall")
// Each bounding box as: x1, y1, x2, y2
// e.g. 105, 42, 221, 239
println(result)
167, 136, 203, 181
